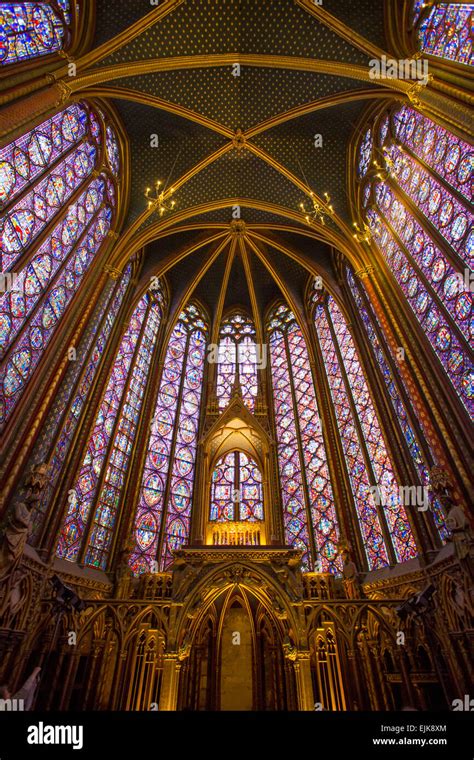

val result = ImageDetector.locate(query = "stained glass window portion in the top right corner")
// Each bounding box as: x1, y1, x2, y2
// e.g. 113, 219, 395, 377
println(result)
414, 0, 473, 64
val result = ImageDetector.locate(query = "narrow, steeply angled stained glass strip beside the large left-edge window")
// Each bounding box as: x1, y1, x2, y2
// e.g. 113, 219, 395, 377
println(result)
29, 265, 131, 545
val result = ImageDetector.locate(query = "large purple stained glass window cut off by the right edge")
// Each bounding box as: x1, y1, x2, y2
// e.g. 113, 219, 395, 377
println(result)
359, 106, 474, 417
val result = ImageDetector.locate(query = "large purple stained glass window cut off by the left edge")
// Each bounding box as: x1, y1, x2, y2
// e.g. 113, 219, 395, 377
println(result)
0, 103, 119, 427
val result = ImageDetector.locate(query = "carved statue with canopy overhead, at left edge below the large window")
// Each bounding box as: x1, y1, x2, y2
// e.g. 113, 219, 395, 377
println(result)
0, 463, 49, 580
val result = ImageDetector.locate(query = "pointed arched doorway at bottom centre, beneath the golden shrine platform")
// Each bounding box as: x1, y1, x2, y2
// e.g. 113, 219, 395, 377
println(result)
178, 586, 298, 711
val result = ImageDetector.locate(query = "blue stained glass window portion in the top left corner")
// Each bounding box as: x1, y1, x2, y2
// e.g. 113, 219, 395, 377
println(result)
0, 0, 76, 66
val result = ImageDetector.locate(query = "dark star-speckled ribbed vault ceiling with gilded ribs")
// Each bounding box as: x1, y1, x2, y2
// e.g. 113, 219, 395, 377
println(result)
61, 0, 392, 324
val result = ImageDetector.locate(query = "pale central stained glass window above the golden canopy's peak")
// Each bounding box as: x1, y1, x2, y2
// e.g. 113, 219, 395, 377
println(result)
217, 314, 258, 409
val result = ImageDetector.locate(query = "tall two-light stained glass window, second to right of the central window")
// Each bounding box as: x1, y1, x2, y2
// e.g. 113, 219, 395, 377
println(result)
312, 289, 417, 569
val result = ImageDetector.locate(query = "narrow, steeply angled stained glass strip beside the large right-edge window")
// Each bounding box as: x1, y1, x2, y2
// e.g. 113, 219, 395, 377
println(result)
346, 268, 448, 540
